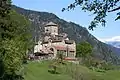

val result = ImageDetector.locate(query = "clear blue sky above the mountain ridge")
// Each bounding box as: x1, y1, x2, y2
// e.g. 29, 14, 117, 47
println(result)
12, 0, 120, 42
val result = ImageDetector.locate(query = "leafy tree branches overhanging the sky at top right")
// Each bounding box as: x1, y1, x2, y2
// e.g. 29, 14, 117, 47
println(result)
62, 0, 120, 30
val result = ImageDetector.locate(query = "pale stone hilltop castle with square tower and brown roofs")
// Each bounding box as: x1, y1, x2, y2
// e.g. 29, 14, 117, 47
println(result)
34, 22, 76, 59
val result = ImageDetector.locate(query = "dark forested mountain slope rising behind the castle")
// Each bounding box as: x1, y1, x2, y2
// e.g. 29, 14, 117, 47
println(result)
12, 6, 119, 64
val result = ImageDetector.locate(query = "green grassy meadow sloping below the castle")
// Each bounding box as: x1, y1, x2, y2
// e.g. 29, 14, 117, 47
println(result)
25, 61, 120, 80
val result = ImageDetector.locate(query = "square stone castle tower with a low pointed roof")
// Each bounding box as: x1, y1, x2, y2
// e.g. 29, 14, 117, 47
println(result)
45, 22, 58, 36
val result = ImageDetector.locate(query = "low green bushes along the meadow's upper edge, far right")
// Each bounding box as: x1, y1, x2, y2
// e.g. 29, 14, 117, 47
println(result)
82, 57, 120, 72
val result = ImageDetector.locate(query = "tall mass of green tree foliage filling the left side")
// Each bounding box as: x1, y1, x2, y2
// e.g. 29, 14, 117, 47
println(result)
0, 0, 31, 80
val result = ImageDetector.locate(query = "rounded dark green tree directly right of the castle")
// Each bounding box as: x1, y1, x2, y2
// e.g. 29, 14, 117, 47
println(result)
76, 42, 92, 58
